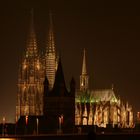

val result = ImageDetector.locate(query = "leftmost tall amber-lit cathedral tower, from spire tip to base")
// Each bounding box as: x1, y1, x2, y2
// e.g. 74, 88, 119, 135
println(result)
16, 10, 44, 119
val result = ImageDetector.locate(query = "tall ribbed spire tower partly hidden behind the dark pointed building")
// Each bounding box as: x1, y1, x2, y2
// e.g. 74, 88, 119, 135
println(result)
45, 13, 57, 89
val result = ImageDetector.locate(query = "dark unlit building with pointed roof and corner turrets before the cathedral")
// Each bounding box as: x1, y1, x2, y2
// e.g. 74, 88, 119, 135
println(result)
44, 60, 75, 132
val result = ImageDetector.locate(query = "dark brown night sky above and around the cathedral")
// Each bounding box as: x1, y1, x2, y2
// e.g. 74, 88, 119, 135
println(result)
0, 0, 140, 122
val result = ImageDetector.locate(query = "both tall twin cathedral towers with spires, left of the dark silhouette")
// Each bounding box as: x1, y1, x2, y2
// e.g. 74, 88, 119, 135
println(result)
16, 11, 57, 120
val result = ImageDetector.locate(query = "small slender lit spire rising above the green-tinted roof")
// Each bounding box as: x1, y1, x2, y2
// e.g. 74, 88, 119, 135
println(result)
80, 49, 89, 91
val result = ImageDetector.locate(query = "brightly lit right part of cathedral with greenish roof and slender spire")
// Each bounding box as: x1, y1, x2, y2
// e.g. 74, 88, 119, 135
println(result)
75, 50, 134, 128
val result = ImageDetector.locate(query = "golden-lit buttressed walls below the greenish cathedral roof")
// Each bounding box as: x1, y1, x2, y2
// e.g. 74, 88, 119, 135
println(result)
75, 93, 134, 128
